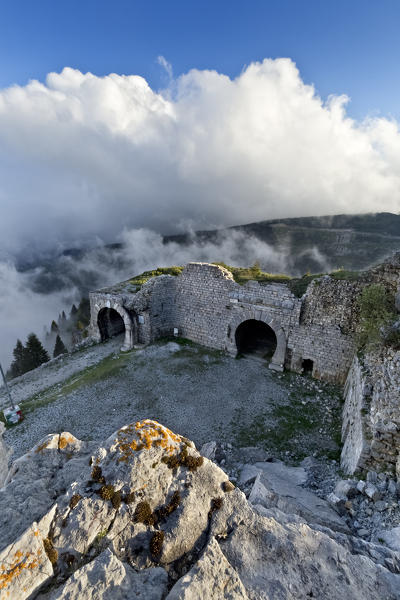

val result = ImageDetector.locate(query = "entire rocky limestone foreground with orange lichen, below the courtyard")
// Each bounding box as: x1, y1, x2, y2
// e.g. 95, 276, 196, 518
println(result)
0, 420, 400, 600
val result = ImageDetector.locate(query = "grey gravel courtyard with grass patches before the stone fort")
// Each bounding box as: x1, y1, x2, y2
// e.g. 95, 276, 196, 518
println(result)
4, 339, 341, 462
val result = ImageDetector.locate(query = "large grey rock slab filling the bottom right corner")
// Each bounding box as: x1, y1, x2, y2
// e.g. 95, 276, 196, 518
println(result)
210, 490, 400, 600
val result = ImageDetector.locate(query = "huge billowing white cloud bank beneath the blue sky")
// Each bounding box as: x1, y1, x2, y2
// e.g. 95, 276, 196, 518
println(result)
0, 57, 400, 258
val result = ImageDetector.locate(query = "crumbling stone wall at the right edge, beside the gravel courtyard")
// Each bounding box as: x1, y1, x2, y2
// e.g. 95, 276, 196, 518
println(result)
341, 348, 400, 476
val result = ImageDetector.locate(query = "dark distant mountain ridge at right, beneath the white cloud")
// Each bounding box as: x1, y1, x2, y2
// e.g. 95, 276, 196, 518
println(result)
165, 213, 400, 273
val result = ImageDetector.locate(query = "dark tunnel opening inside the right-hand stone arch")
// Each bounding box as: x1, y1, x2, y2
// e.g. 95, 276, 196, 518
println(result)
235, 319, 277, 360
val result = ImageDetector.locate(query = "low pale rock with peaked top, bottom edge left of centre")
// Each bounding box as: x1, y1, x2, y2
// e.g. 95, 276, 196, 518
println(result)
49, 550, 168, 600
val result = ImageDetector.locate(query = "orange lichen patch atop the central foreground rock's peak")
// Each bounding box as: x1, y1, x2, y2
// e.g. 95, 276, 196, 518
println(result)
117, 419, 183, 462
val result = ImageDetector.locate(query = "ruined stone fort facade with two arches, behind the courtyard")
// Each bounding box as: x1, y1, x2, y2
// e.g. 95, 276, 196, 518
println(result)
90, 261, 399, 382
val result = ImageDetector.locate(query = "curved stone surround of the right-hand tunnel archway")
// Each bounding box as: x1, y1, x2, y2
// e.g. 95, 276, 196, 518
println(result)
227, 310, 287, 371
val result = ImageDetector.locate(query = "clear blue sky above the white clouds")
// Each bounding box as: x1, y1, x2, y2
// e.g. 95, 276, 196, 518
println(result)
0, 0, 400, 119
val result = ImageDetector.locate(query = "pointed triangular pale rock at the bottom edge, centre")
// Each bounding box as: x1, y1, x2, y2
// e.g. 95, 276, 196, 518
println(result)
166, 538, 248, 600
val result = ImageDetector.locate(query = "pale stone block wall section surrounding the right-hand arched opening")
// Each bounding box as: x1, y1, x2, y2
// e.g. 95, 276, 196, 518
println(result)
174, 263, 301, 370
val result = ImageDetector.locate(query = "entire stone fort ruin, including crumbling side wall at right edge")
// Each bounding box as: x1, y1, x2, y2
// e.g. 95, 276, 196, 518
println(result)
90, 253, 400, 479
